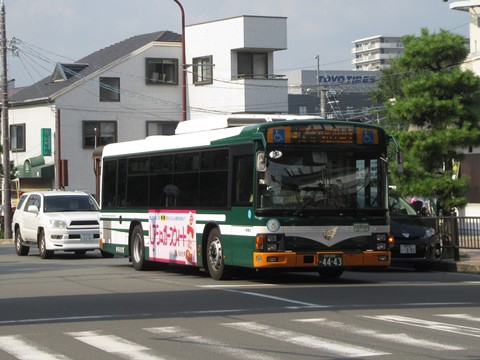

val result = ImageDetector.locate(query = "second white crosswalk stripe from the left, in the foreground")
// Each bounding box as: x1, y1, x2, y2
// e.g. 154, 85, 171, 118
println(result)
65, 331, 162, 360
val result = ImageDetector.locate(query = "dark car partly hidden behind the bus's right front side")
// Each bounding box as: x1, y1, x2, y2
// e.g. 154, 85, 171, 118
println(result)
388, 192, 442, 271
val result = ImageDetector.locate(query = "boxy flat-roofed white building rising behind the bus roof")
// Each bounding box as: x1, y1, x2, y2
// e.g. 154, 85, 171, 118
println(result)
185, 16, 288, 119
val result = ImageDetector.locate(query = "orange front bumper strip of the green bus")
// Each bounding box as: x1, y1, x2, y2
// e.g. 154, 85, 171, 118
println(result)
253, 251, 391, 268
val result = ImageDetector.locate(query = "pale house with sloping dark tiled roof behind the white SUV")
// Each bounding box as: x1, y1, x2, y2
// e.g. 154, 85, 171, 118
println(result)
9, 31, 182, 193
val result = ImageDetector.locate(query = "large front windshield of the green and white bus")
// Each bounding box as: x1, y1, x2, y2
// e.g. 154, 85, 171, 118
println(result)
257, 147, 386, 216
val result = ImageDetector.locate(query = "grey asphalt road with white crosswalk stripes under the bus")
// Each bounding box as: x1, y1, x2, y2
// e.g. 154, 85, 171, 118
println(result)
0, 245, 480, 360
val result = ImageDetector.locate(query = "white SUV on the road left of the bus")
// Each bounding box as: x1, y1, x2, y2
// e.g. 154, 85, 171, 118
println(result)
12, 191, 111, 259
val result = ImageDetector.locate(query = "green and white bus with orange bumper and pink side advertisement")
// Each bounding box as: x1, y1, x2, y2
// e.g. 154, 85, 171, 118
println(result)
100, 116, 390, 280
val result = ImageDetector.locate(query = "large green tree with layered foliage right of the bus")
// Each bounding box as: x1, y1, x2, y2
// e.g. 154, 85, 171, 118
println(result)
373, 29, 480, 211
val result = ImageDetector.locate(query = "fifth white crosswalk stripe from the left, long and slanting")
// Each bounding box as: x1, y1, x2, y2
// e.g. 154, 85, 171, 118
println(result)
293, 318, 464, 351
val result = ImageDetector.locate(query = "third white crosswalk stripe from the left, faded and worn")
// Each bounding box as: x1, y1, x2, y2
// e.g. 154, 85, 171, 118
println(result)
144, 326, 276, 360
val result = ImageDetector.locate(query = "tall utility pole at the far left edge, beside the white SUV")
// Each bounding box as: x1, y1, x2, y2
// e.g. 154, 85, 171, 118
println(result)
0, 0, 12, 239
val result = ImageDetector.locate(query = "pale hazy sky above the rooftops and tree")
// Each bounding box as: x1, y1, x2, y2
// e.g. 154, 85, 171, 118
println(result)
2, 0, 469, 87
